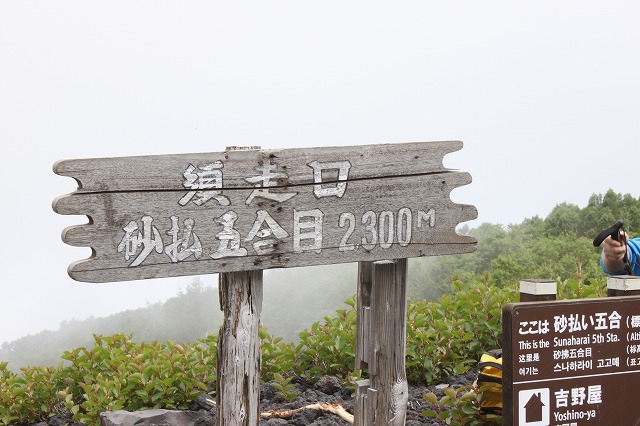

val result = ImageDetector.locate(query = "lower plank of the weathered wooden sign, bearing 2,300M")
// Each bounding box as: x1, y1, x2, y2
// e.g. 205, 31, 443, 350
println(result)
56, 173, 477, 282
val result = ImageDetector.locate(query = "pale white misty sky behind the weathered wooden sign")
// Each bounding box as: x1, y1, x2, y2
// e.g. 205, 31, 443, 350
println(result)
0, 0, 640, 343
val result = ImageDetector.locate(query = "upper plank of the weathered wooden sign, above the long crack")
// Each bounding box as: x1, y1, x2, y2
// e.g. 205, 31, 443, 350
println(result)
53, 141, 462, 193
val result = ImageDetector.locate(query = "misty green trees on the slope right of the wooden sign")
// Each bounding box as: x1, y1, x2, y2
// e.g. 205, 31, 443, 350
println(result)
408, 190, 640, 300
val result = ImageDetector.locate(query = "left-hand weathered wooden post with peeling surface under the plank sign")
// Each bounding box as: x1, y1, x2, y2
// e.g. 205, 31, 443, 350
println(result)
216, 270, 262, 426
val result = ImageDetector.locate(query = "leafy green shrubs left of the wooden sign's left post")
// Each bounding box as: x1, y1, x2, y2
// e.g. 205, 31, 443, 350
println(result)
0, 334, 217, 424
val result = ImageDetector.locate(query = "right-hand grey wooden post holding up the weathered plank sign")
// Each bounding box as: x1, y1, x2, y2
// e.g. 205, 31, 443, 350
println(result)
354, 259, 409, 426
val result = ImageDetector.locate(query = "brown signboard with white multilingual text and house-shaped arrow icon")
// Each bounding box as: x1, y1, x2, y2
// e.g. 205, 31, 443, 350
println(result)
503, 296, 640, 426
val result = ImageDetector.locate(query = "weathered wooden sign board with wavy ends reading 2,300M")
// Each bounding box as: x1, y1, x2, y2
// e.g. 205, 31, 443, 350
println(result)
53, 141, 477, 282
